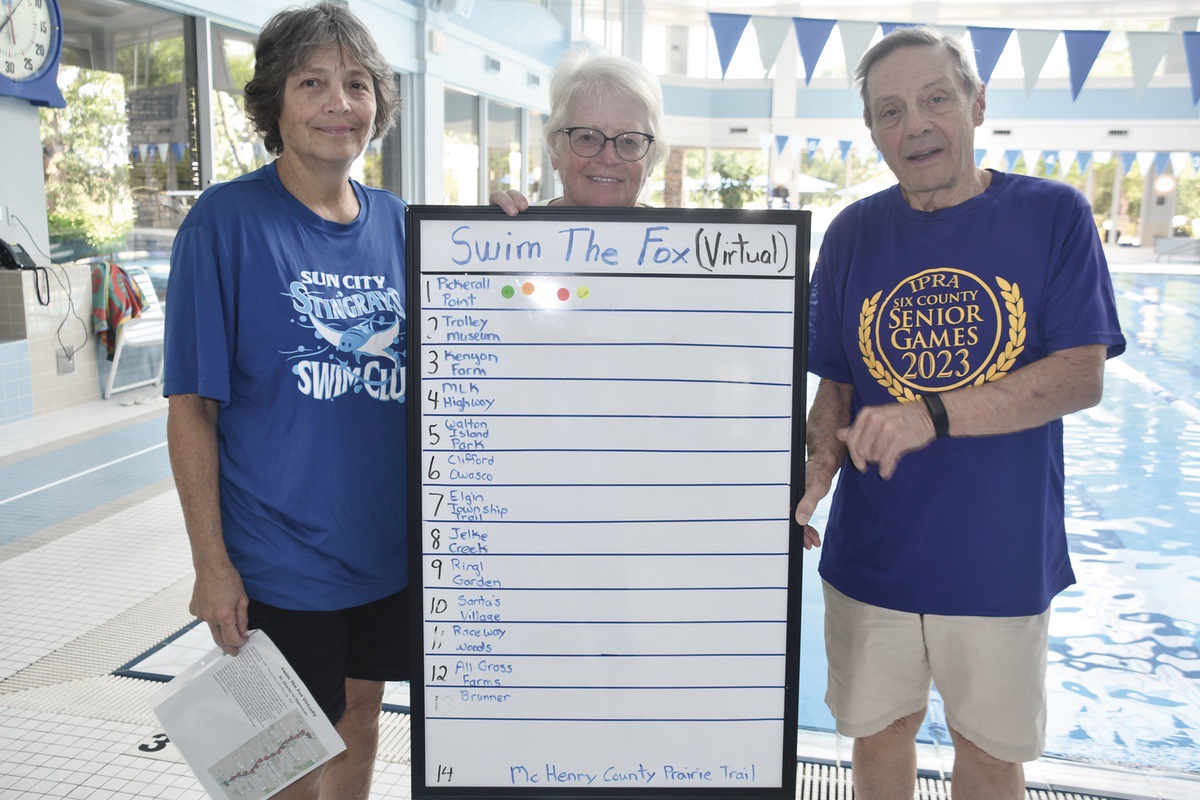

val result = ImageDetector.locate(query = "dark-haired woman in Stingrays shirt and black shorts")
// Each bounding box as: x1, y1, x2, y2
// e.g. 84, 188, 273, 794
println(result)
163, 2, 408, 800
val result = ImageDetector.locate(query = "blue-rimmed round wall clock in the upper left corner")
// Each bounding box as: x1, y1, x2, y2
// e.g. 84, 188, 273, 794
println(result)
0, 0, 66, 108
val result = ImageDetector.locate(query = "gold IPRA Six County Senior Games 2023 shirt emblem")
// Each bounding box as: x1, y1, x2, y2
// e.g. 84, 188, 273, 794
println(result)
858, 266, 1025, 403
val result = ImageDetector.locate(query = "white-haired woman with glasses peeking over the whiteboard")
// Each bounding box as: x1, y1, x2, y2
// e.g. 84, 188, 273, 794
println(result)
490, 48, 667, 216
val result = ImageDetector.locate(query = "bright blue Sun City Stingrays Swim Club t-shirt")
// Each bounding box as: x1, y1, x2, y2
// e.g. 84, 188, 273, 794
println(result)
164, 164, 408, 610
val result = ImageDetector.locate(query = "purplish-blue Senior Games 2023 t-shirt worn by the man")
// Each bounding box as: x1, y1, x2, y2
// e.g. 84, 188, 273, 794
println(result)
809, 172, 1124, 616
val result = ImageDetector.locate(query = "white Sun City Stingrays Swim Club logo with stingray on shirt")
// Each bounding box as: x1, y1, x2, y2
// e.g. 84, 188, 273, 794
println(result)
286, 271, 404, 403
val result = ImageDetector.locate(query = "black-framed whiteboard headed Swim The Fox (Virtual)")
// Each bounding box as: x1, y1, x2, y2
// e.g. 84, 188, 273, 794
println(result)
407, 206, 809, 798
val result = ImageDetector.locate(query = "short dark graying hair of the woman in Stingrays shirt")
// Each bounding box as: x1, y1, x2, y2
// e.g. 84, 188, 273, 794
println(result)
245, 2, 400, 156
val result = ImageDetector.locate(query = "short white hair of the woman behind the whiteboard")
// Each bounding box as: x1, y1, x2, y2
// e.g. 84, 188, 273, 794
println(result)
542, 46, 670, 172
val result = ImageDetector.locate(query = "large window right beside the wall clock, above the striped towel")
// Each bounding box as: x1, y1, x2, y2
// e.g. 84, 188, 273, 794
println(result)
41, 0, 199, 263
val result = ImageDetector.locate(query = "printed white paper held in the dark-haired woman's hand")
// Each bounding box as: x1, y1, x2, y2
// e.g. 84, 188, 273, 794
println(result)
150, 631, 346, 800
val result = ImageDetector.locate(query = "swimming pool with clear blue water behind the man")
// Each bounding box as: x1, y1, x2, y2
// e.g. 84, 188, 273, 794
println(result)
799, 267, 1200, 772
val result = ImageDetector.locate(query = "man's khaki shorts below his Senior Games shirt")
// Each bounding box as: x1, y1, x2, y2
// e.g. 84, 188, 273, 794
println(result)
822, 582, 1050, 763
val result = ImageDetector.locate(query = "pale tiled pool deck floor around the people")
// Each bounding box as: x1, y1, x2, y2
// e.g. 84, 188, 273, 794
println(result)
0, 247, 1200, 800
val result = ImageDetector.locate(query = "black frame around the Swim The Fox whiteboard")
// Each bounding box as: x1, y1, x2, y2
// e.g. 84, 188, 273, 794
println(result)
404, 205, 811, 800
